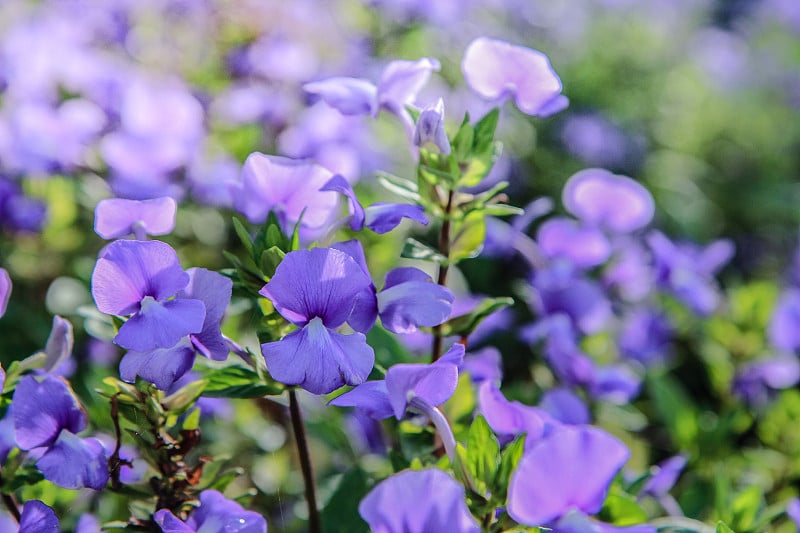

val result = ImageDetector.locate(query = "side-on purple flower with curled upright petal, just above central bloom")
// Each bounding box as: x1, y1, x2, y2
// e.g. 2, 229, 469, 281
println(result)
320, 175, 428, 234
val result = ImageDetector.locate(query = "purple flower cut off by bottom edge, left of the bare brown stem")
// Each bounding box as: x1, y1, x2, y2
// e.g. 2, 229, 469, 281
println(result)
153, 490, 267, 533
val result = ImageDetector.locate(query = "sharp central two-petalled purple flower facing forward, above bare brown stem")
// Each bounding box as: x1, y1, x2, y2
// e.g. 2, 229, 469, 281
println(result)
260, 248, 375, 394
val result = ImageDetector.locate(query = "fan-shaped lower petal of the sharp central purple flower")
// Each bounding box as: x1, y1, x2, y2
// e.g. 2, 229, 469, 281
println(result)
261, 316, 375, 394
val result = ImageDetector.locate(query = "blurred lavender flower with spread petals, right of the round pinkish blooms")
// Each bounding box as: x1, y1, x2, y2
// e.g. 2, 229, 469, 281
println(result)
647, 231, 734, 316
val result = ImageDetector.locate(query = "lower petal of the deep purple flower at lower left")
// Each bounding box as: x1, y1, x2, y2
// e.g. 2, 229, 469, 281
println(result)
36, 431, 108, 490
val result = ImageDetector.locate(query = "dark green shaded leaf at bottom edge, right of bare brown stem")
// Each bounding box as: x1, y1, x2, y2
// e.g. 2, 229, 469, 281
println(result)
321, 468, 369, 533
